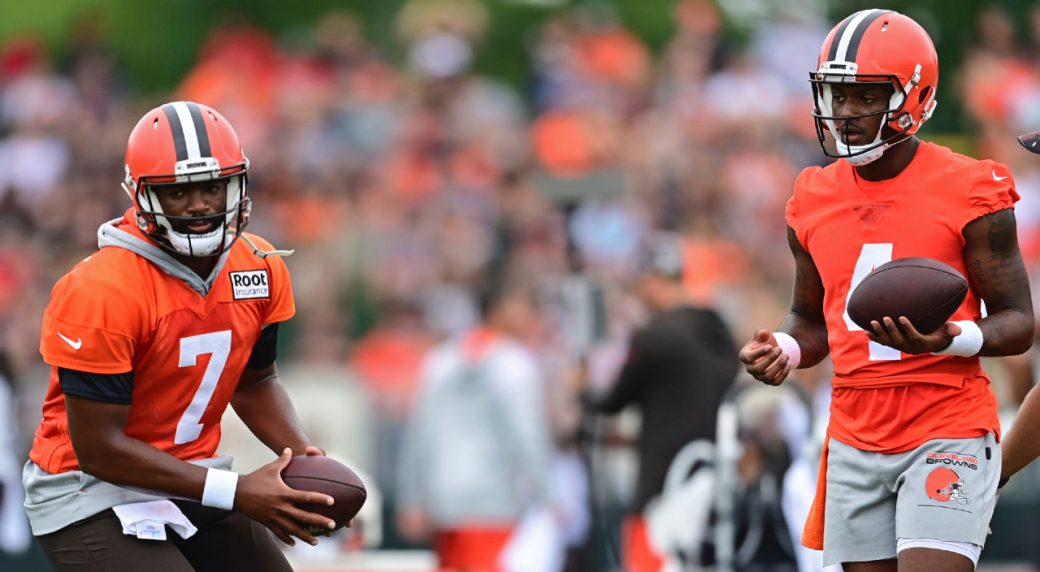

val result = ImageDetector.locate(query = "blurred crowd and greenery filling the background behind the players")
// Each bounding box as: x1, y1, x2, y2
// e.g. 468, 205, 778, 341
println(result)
0, 0, 1040, 570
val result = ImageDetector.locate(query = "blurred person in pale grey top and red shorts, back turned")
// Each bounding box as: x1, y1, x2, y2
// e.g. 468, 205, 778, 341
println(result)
397, 286, 552, 572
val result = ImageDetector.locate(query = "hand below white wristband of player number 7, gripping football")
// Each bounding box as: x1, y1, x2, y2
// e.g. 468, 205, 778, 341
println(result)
235, 447, 335, 546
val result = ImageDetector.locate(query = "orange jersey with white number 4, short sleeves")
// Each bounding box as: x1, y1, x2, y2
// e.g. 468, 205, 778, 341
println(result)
787, 142, 1018, 452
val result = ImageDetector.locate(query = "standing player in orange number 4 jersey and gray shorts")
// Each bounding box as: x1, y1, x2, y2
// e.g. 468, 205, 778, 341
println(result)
740, 9, 1034, 572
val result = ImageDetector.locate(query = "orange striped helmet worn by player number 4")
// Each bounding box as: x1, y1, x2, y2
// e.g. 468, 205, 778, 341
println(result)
809, 9, 939, 165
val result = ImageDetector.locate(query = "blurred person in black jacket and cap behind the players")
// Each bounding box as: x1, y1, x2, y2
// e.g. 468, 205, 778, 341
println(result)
590, 234, 737, 572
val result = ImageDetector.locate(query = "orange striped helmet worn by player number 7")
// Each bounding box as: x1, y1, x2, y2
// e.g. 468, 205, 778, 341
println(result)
123, 101, 251, 257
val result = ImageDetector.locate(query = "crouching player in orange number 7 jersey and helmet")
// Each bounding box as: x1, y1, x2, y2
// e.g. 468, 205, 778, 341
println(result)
23, 102, 333, 572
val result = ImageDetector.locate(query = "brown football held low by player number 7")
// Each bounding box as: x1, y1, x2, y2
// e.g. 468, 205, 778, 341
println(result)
282, 454, 368, 531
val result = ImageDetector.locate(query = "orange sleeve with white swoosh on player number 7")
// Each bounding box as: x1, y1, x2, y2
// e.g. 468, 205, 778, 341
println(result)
40, 272, 141, 373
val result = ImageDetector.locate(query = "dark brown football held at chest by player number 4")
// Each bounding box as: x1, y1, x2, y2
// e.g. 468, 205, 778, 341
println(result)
849, 258, 968, 334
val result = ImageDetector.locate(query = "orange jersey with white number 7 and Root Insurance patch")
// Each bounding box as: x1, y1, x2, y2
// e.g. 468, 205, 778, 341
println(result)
29, 211, 295, 473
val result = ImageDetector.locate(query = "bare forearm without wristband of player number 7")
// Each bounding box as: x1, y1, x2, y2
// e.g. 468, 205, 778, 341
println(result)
231, 378, 312, 454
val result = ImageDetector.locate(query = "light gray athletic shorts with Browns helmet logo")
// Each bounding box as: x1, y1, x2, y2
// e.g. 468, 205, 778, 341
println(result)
824, 434, 1000, 566
